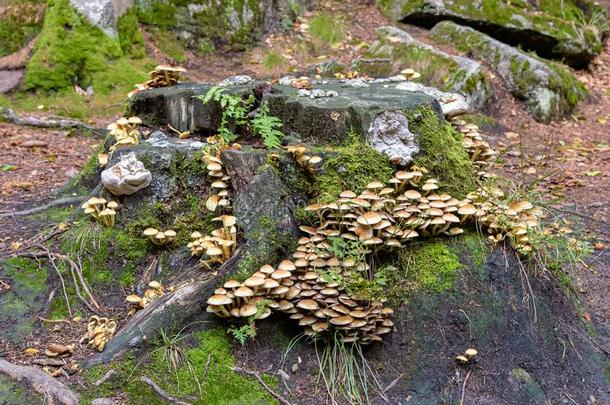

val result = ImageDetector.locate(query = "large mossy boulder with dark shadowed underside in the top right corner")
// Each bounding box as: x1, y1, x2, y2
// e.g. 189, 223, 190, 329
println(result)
378, 0, 608, 67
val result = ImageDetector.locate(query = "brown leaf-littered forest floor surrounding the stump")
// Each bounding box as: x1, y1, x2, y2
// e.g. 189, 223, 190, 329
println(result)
0, 1, 610, 376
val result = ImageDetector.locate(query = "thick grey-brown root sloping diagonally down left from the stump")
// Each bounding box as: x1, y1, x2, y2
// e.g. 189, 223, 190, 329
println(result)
84, 247, 242, 367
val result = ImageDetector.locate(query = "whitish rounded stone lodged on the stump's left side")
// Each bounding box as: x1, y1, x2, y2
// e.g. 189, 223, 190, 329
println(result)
102, 152, 152, 195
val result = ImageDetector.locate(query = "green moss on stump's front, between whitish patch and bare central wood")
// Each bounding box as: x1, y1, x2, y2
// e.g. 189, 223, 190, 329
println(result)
313, 131, 394, 201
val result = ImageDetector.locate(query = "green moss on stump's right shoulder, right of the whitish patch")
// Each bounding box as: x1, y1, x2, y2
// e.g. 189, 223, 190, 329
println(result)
407, 106, 476, 198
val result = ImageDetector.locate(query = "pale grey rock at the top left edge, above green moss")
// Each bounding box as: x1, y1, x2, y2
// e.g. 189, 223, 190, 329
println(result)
70, 0, 132, 37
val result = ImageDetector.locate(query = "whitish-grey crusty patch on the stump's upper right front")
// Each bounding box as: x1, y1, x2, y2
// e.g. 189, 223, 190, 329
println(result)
367, 111, 419, 165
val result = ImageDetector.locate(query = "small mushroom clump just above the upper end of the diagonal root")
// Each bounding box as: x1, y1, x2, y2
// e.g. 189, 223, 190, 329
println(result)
187, 215, 237, 270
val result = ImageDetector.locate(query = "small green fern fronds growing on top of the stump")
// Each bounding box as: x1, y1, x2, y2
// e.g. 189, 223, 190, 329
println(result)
195, 86, 254, 143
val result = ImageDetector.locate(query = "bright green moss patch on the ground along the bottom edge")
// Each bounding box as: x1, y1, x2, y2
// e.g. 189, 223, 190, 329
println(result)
81, 328, 277, 405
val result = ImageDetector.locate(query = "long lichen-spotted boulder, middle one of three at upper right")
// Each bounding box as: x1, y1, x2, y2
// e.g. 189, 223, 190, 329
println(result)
430, 21, 587, 122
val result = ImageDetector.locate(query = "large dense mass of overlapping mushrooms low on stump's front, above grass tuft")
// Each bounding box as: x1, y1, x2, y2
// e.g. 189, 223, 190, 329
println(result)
207, 258, 394, 344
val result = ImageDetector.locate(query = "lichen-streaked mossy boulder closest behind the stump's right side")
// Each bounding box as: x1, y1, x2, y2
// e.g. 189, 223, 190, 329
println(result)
367, 26, 492, 109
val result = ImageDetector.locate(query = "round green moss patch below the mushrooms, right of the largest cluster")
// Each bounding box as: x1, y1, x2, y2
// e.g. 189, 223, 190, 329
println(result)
400, 241, 462, 293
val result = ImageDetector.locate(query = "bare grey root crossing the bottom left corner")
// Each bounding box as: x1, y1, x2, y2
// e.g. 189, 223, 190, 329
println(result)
0, 359, 79, 405
